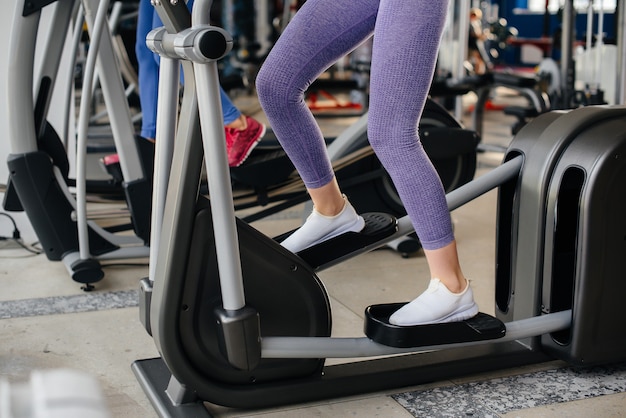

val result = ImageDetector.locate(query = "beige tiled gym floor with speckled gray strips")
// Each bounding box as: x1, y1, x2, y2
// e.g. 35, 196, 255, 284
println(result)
0, 91, 626, 418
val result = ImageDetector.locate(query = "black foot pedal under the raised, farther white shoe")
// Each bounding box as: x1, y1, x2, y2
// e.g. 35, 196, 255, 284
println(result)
298, 212, 398, 269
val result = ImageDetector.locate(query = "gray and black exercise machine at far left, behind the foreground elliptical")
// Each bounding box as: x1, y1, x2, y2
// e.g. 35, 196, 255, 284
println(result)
3, 0, 151, 284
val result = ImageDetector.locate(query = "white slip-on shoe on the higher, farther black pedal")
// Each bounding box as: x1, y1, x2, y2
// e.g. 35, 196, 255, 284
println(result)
281, 196, 365, 253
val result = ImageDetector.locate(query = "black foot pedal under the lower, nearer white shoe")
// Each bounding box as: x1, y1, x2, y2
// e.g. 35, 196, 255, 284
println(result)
365, 303, 506, 348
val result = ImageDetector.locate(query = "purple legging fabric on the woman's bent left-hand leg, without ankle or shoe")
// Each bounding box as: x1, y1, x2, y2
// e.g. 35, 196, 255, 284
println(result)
255, 0, 378, 189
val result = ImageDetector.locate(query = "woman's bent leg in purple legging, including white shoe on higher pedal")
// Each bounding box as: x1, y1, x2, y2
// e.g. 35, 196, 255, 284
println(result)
256, 0, 378, 252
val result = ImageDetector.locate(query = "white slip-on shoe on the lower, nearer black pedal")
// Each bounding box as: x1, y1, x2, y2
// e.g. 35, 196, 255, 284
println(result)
389, 279, 478, 326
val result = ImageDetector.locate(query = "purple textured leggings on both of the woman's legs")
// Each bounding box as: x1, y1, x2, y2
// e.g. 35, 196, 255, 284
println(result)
256, 0, 454, 250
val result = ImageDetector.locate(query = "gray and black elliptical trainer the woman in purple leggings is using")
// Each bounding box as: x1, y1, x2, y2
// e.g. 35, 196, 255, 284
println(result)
132, 0, 626, 416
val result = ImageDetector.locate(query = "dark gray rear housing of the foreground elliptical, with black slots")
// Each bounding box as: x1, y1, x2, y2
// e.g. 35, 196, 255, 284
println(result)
496, 106, 626, 365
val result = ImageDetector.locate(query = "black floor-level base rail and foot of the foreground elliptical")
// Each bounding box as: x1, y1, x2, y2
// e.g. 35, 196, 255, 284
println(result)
132, 341, 552, 417
